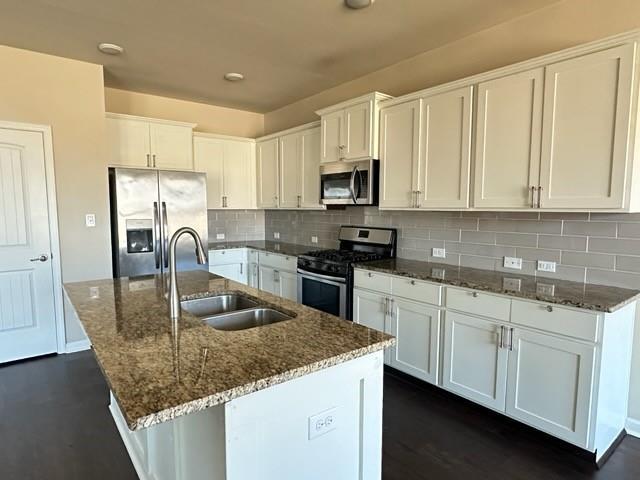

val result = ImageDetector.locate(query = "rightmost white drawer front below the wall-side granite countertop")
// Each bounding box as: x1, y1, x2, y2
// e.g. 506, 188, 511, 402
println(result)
511, 300, 599, 342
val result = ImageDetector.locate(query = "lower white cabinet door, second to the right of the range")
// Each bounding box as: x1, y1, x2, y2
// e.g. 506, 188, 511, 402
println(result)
389, 298, 440, 385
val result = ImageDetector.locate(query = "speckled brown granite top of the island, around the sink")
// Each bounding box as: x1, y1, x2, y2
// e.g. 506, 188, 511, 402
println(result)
65, 271, 394, 430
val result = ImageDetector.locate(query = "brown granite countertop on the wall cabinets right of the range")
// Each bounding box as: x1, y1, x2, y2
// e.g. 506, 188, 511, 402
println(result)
356, 258, 640, 313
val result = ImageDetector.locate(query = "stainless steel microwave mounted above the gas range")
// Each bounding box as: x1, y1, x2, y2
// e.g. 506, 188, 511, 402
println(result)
320, 160, 379, 205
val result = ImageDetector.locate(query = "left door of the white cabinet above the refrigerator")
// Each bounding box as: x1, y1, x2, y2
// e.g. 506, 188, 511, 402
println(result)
106, 117, 151, 167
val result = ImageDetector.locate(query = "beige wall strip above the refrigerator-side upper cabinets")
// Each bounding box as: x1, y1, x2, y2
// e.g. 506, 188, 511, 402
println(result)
104, 88, 264, 138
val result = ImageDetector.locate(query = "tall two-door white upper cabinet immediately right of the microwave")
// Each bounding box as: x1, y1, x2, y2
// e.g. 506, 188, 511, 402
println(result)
380, 87, 472, 209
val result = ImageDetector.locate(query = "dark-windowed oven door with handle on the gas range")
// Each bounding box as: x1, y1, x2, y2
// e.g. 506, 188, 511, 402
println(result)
298, 269, 347, 318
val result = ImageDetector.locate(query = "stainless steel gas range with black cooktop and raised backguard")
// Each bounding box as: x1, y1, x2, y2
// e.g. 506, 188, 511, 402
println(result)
298, 226, 397, 320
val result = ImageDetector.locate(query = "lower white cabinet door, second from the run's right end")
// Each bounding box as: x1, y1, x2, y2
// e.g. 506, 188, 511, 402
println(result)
442, 311, 508, 412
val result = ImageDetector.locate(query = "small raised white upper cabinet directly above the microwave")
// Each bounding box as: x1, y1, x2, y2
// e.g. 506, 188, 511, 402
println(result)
316, 92, 391, 163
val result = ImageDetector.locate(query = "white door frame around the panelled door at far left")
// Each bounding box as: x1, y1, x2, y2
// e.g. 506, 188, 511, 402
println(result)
0, 120, 67, 353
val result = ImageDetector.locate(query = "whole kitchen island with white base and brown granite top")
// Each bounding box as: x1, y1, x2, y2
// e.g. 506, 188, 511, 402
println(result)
65, 271, 394, 480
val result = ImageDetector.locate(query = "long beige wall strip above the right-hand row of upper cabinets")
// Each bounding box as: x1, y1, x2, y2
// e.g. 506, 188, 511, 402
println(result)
265, 0, 640, 134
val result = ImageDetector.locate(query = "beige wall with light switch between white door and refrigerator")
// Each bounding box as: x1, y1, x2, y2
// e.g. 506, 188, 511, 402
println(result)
0, 46, 111, 282
